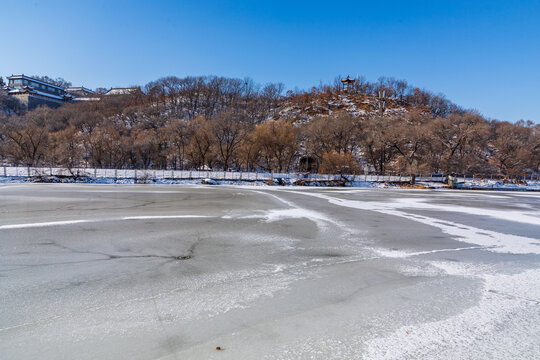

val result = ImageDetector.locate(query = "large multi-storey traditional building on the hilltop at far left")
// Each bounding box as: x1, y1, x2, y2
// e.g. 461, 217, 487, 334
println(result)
8, 74, 70, 110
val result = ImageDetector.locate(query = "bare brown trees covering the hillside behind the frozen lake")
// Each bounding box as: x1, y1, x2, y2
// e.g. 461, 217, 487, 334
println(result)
0, 77, 540, 177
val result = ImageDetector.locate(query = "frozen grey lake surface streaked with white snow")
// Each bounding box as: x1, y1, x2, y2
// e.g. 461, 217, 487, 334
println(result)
0, 184, 540, 359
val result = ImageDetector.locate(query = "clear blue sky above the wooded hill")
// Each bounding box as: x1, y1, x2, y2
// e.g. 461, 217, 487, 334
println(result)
0, 0, 540, 122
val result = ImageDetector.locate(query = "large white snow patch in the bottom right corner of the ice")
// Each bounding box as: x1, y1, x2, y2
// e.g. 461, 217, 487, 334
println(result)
363, 263, 540, 359
